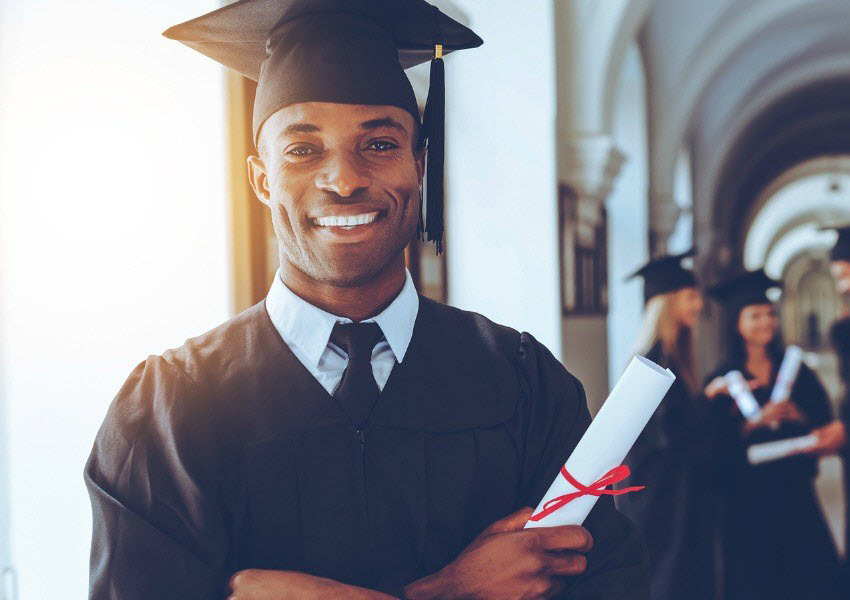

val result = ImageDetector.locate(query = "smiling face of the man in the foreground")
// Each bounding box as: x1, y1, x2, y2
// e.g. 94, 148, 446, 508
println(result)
248, 102, 423, 287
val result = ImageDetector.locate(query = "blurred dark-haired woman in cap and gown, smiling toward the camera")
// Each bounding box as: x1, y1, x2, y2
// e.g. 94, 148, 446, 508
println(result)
705, 270, 839, 600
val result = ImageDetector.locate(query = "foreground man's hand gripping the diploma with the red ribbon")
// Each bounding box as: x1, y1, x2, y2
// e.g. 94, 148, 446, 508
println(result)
404, 508, 593, 600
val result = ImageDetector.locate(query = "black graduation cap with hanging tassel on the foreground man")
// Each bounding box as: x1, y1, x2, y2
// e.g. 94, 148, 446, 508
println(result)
163, 0, 483, 252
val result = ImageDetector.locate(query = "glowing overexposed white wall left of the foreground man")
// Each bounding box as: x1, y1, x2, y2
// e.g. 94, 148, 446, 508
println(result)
0, 0, 229, 600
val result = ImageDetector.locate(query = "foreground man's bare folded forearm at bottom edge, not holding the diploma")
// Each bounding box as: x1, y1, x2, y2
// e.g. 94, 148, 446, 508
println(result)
227, 569, 392, 600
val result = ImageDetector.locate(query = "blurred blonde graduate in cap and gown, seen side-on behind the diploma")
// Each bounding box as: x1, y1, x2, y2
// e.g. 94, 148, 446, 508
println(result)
616, 250, 714, 600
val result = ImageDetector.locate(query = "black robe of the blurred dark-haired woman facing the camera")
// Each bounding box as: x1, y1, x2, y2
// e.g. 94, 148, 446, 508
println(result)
708, 356, 841, 600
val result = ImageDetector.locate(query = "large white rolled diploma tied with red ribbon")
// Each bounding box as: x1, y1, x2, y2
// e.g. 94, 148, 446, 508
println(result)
525, 356, 676, 528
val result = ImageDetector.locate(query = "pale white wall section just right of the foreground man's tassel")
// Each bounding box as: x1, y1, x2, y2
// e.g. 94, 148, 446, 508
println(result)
446, 0, 561, 356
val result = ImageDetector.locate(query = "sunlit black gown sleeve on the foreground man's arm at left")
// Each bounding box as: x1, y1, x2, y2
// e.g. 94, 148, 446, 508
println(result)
84, 356, 229, 600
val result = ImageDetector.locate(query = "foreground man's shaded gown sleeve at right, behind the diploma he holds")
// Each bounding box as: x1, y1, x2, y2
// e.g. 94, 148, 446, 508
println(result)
521, 334, 649, 600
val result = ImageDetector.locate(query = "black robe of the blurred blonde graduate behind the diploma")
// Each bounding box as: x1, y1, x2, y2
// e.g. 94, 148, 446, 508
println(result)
616, 342, 715, 600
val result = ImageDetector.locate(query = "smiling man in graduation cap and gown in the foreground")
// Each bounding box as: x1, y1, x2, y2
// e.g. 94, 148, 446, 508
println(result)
85, 0, 648, 600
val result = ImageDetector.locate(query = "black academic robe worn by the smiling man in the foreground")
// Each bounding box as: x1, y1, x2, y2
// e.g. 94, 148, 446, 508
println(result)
85, 298, 648, 600
